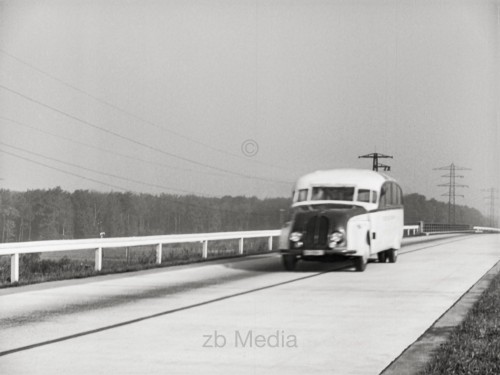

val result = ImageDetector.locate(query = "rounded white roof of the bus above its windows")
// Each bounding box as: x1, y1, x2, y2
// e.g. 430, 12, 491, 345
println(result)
295, 169, 395, 190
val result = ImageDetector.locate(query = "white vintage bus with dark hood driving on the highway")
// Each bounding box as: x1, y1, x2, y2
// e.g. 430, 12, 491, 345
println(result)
280, 169, 404, 271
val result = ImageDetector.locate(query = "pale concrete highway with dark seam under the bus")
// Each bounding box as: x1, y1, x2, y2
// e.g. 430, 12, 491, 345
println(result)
0, 234, 500, 375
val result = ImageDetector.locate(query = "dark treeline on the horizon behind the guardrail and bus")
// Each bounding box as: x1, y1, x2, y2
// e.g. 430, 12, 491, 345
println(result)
0, 187, 486, 242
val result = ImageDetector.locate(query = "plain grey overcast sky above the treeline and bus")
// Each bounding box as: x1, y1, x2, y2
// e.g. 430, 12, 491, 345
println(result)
0, 0, 500, 212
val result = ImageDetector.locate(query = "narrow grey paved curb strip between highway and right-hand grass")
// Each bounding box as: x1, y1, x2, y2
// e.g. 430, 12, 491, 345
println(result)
380, 261, 500, 375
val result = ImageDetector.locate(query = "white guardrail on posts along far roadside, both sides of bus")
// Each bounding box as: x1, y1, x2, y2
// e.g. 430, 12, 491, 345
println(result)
0, 225, 494, 283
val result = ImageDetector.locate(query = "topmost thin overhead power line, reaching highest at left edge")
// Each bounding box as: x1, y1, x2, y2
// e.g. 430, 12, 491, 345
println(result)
0, 49, 285, 169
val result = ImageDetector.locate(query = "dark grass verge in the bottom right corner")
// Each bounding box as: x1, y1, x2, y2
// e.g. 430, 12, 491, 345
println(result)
420, 274, 500, 375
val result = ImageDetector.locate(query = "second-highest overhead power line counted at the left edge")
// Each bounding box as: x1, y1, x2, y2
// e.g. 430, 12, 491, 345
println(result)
0, 84, 289, 184
